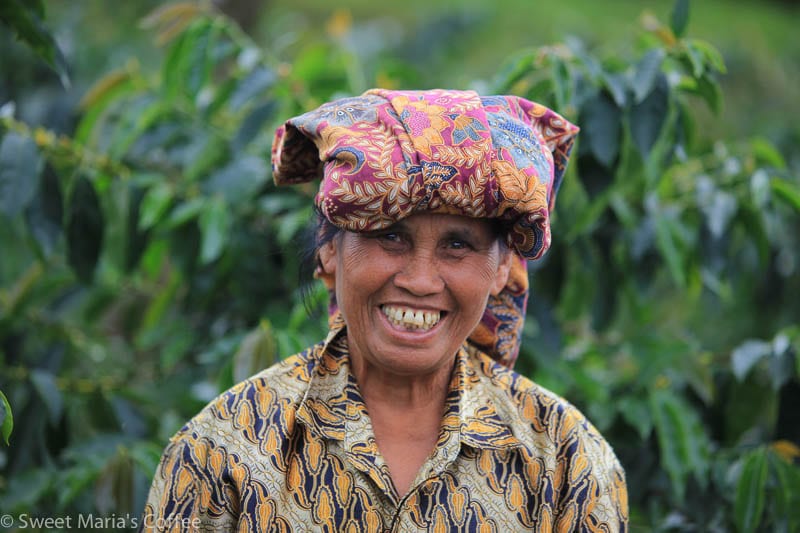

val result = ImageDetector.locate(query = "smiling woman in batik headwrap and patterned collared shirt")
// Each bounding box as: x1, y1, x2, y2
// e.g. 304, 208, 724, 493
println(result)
142, 90, 628, 532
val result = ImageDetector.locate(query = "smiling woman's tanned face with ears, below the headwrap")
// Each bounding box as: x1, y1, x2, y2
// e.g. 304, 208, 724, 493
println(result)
320, 213, 512, 376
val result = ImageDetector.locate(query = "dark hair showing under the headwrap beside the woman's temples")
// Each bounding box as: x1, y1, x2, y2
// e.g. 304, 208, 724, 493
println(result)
299, 208, 511, 317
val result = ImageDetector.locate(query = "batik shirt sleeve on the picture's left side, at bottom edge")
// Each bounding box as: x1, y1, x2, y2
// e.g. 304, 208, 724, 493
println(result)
139, 433, 239, 533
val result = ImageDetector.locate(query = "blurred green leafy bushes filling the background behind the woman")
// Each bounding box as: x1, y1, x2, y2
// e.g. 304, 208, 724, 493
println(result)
0, 0, 800, 531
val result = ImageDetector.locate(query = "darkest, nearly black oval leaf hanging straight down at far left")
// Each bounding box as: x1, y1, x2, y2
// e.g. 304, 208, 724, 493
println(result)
67, 176, 105, 283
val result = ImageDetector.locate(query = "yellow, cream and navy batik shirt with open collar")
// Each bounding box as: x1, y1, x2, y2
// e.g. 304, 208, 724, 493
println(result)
141, 324, 628, 533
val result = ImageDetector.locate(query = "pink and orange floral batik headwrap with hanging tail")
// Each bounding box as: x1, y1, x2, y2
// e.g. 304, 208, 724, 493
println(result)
272, 89, 578, 367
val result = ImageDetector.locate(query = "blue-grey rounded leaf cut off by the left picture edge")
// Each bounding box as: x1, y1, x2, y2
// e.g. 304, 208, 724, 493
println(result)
0, 131, 43, 217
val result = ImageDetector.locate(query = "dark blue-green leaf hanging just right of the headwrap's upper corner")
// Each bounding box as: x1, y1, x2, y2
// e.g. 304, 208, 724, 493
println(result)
580, 91, 622, 168
